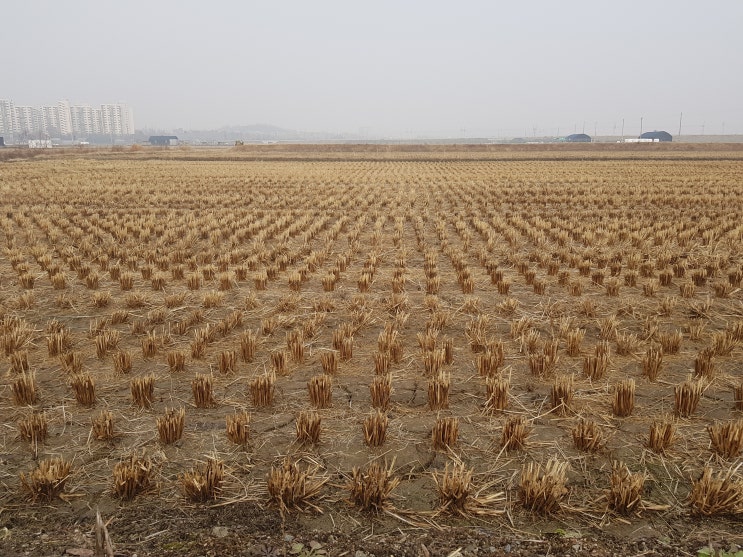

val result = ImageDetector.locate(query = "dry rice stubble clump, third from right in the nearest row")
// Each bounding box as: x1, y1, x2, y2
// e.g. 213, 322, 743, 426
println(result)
519, 459, 568, 514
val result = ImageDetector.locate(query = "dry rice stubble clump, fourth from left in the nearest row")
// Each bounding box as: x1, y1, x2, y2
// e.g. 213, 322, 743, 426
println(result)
266, 457, 328, 516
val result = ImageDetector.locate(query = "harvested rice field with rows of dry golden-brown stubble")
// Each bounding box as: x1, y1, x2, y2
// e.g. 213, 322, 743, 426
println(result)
0, 145, 743, 555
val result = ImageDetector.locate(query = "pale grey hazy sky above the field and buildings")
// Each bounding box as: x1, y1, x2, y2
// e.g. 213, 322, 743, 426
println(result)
0, 0, 743, 137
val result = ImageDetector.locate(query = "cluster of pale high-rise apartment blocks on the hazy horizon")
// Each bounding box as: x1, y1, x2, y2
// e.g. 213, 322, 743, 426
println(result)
0, 99, 134, 141
